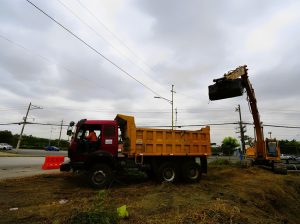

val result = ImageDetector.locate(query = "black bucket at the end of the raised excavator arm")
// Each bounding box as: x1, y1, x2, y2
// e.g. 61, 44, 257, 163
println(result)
208, 79, 244, 100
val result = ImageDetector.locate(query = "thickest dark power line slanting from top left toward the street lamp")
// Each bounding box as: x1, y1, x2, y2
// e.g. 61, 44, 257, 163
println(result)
26, 0, 160, 96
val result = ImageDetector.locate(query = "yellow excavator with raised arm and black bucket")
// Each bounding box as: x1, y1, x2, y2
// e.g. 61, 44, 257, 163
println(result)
208, 65, 286, 173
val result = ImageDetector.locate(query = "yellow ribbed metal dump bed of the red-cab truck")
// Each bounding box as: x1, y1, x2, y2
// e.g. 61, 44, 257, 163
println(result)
115, 114, 211, 156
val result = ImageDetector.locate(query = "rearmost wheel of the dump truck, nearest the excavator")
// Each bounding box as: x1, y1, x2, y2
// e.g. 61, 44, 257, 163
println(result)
182, 161, 201, 183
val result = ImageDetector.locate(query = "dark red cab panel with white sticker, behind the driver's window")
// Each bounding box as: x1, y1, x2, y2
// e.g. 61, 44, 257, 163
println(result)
100, 124, 118, 155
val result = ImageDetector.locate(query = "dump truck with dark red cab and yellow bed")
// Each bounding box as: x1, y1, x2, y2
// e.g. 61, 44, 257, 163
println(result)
60, 114, 211, 188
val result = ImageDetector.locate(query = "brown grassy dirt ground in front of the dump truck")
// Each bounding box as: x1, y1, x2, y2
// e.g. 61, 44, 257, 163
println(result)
0, 165, 300, 224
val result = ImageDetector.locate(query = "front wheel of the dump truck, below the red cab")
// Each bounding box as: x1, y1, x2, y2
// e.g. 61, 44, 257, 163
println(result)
89, 164, 112, 188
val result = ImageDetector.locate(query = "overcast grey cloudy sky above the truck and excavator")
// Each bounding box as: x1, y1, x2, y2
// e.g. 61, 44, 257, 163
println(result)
0, 0, 300, 144
